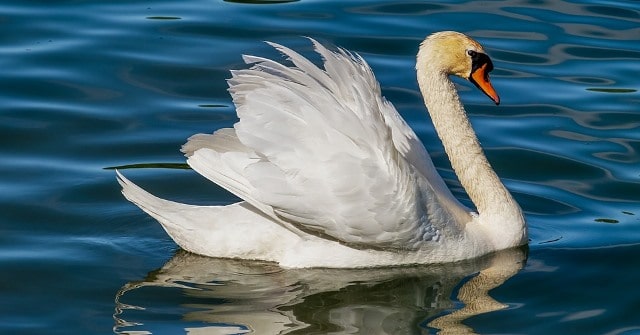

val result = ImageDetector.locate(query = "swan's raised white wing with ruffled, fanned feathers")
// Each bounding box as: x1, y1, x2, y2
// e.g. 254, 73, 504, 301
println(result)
187, 42, 458, 248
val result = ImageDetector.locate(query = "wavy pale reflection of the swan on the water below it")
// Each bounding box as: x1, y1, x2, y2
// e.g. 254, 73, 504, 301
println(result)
114, 249, 526, 335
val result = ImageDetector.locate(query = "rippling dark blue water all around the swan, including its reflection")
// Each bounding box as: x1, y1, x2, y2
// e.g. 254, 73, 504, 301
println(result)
0, 0, 640, 334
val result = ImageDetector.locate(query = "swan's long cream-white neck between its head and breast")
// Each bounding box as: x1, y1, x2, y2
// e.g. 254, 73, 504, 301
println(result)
416, 57, 526, 247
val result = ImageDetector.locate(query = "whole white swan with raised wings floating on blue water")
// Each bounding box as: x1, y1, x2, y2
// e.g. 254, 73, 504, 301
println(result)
116, 31, 527, 268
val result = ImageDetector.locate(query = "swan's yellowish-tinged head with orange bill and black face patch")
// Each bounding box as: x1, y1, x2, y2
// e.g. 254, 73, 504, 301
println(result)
416, 31, 500, 105
